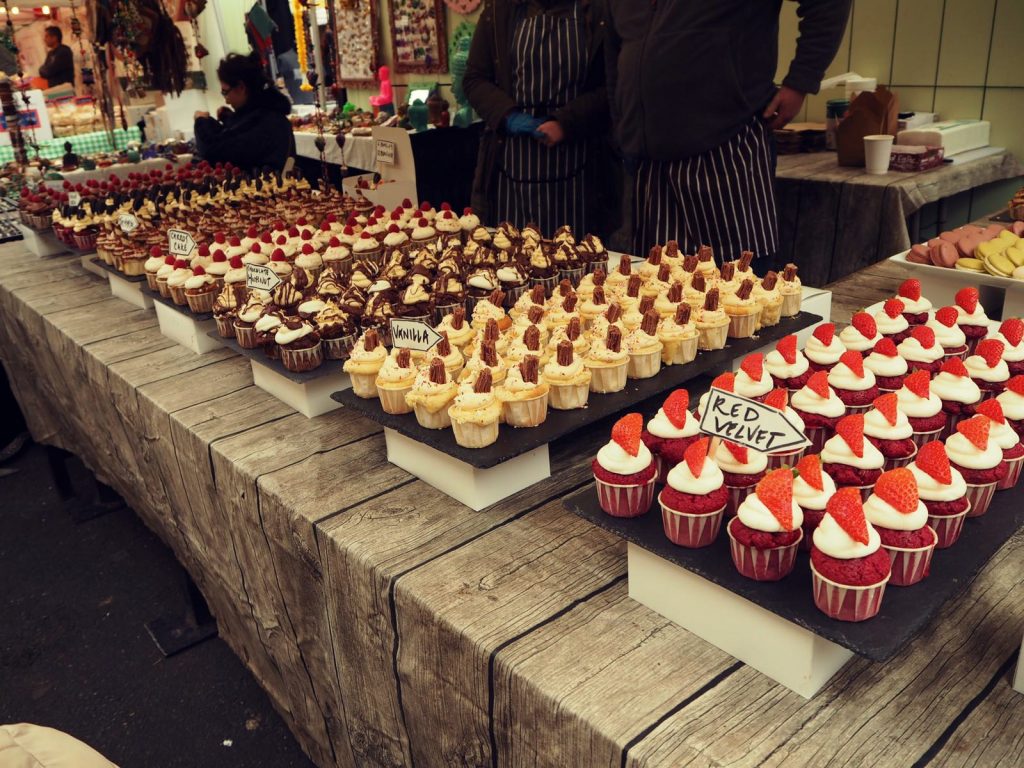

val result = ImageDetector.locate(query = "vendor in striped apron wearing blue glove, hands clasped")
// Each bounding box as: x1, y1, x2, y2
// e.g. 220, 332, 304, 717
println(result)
463, 0, 613, 234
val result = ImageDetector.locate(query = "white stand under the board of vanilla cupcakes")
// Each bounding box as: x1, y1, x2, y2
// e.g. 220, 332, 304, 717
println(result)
384, 427, 551, 510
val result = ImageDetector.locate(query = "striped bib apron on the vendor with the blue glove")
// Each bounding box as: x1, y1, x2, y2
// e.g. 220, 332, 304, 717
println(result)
495, 3, 589, 236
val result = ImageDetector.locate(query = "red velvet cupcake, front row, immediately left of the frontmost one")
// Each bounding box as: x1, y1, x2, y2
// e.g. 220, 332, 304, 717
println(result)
727, 469, 804, 582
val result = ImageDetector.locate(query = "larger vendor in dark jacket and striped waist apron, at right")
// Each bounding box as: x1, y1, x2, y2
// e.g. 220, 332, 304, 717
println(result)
606, 0, 850, 264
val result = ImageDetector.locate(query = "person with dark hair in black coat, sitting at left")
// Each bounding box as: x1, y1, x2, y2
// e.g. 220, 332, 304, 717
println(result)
196, 53, 295, 171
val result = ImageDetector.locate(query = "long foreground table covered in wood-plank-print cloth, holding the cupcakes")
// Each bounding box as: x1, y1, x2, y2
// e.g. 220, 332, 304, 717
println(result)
0, 245, 1024, 768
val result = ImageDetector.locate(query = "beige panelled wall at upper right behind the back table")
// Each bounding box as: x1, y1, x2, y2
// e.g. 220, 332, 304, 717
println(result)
778, 0, 1024, 218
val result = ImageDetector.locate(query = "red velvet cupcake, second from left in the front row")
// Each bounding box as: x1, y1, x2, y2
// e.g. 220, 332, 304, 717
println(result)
657, 437, 728, 549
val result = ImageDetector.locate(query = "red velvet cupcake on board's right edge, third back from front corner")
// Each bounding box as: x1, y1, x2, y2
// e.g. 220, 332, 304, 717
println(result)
907, 440, 971, 549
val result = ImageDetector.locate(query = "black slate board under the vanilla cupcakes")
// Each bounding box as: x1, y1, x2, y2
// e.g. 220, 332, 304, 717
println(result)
331, 312, 821, 469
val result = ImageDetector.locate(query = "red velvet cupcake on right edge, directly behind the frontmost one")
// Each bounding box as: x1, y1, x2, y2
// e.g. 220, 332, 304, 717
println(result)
864, 467, 938, 587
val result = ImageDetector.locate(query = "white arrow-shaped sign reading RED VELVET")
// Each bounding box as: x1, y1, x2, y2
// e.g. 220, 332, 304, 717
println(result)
700, 387, 810, 454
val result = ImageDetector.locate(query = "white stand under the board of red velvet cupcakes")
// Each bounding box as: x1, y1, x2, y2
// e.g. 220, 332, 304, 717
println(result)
629, 544, 854, 698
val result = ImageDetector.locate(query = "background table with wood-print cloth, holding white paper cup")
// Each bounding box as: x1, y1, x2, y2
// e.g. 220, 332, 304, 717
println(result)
775, 147, 1024, 286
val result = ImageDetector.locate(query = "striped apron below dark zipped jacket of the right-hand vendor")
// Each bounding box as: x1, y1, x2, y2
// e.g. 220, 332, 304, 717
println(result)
634, 116, 778, 262
